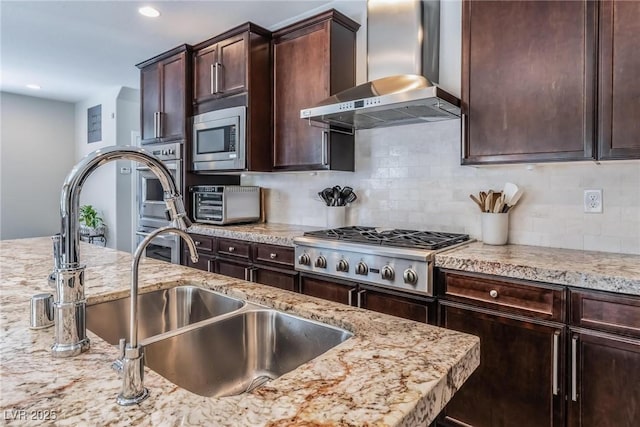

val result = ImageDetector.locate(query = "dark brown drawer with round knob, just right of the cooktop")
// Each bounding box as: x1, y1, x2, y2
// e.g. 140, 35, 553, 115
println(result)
444, 272, 564, 321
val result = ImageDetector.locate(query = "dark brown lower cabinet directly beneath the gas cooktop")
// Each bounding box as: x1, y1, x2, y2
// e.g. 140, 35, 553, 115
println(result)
300, 274, 435, 324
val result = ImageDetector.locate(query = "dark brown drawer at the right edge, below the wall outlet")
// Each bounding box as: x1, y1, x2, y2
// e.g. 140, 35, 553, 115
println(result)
569, 289, 640, 338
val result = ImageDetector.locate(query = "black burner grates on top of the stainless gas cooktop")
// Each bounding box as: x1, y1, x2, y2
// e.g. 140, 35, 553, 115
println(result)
304, 226, 469, 250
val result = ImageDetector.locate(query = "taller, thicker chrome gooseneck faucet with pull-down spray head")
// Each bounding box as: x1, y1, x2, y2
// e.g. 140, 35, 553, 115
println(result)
51, 146, 191, 357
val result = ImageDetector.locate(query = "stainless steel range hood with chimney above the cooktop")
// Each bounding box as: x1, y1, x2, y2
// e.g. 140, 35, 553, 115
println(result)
300, 0, 460, 130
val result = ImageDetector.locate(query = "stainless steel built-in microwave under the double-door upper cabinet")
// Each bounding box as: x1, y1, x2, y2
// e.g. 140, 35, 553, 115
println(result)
192, 107, 247, 173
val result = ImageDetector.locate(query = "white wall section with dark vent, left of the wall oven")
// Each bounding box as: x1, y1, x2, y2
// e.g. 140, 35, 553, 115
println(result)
75, 87, 140, 251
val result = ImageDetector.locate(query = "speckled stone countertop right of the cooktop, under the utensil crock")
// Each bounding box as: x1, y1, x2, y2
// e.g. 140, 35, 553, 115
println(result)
436, 242, 640, 295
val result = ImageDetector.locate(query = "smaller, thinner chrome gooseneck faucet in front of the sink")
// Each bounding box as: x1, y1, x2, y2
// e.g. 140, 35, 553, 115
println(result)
114, 227, 198, 406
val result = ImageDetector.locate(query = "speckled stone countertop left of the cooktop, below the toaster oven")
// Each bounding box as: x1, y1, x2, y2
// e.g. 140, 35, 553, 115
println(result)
189, 222, 320, 246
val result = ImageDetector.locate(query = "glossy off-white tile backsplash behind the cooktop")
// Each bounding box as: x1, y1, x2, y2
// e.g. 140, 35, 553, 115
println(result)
242, 120, 640, 254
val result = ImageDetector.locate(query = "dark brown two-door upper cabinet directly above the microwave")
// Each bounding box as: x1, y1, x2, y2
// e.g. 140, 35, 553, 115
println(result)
193, 22, 271, 114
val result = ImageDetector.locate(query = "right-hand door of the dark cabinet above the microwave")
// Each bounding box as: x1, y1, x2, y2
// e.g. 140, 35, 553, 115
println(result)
220, 35, 248, 96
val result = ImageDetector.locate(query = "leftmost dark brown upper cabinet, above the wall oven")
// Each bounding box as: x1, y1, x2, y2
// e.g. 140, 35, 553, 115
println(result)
136, 45, 191, 144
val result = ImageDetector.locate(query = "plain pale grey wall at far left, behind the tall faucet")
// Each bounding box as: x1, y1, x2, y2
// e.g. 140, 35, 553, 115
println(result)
0, 92, 75, 239
